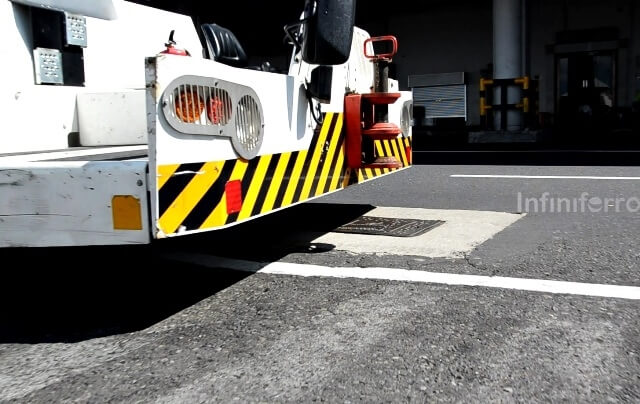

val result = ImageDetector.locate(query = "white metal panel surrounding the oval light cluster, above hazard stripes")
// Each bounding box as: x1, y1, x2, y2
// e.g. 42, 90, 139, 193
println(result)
151, 55, 315, 165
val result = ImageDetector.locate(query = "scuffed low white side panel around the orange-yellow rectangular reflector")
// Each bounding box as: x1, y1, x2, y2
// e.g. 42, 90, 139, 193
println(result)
0, 161, 150, 247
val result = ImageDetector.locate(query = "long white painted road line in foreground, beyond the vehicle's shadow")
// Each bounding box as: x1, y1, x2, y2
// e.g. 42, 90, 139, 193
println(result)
167, 253, 640, 300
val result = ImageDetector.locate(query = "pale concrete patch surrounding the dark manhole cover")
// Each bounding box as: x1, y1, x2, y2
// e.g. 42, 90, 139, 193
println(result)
314, 207, 524, 258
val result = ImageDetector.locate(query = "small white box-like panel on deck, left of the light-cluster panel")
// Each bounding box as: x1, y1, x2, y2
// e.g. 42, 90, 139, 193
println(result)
78, 90, 147, 146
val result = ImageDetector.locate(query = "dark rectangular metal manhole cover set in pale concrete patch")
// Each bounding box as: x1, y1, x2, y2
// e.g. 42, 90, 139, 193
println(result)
333, 216, 444, 237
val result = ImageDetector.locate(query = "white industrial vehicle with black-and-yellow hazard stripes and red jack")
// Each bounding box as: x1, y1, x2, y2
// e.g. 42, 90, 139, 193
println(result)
0, 0, 412, 247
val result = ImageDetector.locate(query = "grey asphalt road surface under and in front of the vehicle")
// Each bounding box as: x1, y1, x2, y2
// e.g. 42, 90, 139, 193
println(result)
0, 166, 640, 403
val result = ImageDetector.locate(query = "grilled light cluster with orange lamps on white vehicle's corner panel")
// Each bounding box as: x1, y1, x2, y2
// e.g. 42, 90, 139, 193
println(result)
162, 76, 264, 159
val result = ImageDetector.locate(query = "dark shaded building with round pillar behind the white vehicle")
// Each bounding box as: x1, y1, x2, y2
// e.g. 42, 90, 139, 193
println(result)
139, 0, 640, 147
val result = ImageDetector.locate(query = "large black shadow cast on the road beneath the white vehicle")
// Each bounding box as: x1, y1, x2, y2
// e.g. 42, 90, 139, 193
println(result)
0, 204, 373, 343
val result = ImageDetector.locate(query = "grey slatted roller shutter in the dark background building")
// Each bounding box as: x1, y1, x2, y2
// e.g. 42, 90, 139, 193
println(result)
413, 85, 467, 119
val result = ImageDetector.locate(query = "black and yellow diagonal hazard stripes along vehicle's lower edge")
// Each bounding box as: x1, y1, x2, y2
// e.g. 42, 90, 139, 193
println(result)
157, 113, 410, 235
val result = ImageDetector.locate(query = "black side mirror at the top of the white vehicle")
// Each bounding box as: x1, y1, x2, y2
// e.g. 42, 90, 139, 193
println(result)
302, 0, 356, 65
